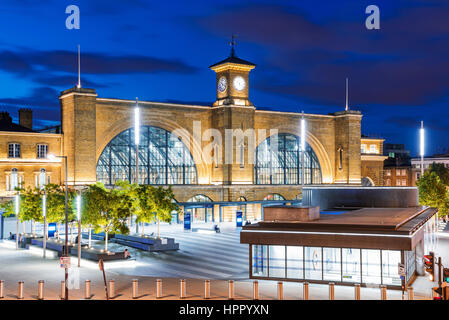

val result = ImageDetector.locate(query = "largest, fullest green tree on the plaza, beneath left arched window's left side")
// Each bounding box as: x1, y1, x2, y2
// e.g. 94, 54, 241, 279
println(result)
82, 182, 130, 251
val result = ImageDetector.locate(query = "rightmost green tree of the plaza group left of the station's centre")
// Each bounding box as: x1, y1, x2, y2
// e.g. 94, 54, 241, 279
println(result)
150, 186, 179, 239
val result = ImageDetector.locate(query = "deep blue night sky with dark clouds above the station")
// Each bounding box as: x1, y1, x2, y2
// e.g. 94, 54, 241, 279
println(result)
0, 0, 449, 155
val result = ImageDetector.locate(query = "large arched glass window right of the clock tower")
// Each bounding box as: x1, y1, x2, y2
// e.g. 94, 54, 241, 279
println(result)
254, 133, 321, 184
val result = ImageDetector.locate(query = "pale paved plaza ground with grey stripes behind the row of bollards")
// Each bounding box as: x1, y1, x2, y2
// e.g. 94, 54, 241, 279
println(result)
0, 221, 449, 300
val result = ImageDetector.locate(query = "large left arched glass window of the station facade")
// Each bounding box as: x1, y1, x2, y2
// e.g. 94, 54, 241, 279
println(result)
97, 126, 198, 185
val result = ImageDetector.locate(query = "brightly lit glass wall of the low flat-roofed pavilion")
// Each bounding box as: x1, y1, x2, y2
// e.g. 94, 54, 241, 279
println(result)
252, 245, 404, 286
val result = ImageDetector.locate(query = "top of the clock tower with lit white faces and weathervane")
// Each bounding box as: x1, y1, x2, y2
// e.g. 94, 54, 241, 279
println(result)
209, 37, 256, 106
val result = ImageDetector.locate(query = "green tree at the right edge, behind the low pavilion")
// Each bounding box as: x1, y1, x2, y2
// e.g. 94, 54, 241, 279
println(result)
416, 163, 449, 216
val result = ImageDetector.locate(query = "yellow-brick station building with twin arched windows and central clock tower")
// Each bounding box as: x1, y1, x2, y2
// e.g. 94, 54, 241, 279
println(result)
0, 52, 384, 221
